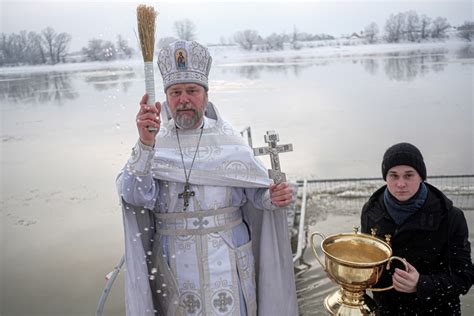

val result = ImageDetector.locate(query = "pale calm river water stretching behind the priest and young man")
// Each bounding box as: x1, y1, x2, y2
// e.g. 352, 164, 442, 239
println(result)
0, 43, 474, 315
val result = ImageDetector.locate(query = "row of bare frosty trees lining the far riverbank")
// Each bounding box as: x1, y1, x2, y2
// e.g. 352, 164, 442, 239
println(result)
0, 15, 474, 66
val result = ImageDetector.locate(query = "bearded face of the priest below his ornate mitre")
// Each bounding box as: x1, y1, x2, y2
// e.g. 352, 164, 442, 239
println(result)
166, 83, 207, 129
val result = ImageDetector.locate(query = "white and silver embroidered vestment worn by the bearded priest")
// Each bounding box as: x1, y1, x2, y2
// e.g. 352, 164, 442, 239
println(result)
118, 103, 297, 316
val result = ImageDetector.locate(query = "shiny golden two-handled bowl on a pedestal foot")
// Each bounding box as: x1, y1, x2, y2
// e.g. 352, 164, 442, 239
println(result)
310, 227, 408, 316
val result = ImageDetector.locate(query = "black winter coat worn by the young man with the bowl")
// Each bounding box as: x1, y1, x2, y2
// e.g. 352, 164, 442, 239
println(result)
361, 183, 474, 316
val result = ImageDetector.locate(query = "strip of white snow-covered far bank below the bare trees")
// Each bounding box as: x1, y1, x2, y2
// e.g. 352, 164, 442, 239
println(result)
0, 39, 474, 74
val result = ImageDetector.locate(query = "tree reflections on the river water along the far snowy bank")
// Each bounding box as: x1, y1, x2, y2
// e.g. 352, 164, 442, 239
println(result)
0, 43, 474, 103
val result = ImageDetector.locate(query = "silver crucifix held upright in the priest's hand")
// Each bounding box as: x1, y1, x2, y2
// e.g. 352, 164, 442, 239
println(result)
253, 131, 293, 183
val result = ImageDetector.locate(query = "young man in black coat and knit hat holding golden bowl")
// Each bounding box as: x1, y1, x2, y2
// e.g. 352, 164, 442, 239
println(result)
361, 143, 474, 315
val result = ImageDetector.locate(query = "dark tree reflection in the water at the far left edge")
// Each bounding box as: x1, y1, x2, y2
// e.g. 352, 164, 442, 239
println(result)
0, 72, 78, 103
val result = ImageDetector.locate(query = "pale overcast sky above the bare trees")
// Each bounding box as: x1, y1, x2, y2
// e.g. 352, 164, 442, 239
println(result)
0, 0, 474, 51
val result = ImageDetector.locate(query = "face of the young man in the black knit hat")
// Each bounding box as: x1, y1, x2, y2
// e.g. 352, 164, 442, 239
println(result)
386, 165, 423, 202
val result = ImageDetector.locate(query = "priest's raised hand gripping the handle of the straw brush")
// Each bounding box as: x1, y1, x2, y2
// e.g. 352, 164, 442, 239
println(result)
136, 93, 161, 147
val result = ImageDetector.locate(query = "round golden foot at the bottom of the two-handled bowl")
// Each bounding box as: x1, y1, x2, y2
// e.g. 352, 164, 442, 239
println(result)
324, 289, 378, 316
